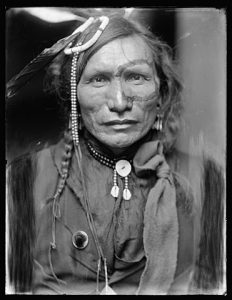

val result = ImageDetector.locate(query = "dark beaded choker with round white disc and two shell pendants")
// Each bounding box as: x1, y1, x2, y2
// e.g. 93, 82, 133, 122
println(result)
87, 143, 132, 200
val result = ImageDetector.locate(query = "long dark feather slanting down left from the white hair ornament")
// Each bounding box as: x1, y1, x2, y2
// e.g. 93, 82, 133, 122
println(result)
6, 32, 80, 99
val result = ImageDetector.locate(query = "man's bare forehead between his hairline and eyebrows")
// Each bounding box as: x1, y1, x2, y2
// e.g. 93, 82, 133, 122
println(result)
84, 36, 152, 72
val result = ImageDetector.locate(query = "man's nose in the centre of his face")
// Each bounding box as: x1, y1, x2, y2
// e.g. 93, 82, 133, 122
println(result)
108, 80, 132, 113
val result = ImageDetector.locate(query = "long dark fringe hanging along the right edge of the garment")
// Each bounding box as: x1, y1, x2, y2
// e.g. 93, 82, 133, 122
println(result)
193, 156, 225, 293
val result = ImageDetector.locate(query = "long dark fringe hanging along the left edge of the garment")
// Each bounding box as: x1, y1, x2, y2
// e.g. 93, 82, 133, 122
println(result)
7, 154, 36, 293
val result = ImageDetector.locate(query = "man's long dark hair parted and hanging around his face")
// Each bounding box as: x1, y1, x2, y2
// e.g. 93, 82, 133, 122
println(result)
45, 15, 183, 151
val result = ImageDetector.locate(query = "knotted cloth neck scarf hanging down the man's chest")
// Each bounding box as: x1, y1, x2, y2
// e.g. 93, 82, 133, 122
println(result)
133, 141, 178, 295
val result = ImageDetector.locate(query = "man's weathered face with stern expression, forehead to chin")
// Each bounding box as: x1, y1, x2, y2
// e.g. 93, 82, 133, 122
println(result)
77, 36, 159, 153
